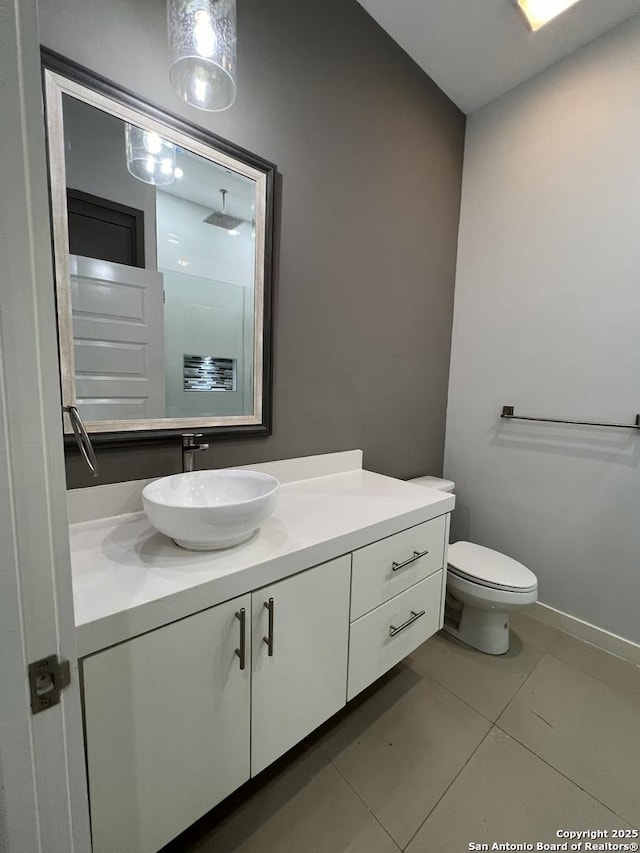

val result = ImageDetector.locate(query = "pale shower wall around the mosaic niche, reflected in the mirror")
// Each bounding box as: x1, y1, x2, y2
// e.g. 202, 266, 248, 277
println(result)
156, 190, 255, 417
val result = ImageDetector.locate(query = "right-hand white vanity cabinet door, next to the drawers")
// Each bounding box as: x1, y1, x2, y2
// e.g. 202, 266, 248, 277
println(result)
251, 555, 351, 775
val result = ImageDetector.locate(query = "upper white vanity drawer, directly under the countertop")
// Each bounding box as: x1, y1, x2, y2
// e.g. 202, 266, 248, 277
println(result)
351, 515, 447, 620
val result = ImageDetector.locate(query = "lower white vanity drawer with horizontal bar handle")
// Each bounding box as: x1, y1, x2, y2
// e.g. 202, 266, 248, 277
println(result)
347, 571, 443, 699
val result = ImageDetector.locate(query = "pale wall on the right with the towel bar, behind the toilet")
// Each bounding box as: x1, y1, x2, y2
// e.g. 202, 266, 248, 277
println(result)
444, 18, 640, 642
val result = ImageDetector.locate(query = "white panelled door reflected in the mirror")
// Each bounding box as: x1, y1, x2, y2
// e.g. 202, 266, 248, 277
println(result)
69, 255, 166, 421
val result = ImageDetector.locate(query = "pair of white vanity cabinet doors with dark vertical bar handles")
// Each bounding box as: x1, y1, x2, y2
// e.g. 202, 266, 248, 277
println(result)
83, 555, 351, 853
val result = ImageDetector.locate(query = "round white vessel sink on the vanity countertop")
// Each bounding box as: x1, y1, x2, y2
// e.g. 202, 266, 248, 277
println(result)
142, 469, 280, 551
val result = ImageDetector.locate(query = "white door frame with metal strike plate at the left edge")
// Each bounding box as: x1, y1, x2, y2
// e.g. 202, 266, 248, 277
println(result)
0, 0, 90, 853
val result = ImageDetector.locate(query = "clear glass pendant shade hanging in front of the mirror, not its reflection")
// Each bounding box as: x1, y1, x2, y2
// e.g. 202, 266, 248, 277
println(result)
167, 0, 236, 112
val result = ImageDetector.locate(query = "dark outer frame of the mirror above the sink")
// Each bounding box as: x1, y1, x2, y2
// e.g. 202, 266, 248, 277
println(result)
41, 46, 277, 448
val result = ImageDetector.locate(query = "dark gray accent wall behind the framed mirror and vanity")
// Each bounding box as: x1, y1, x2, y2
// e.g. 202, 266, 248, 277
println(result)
39, 0, 465, 487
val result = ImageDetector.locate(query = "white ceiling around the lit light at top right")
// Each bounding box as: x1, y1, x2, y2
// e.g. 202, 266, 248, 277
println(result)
358, 0, 640, 113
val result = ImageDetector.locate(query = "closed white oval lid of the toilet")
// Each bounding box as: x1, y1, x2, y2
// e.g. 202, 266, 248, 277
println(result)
448, 542, 538, 592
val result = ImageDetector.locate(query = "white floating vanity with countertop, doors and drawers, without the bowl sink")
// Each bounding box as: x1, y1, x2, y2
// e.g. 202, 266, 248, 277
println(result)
71, 451, 454, 853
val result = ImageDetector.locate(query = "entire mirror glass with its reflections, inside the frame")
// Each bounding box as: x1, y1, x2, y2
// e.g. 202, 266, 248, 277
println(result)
62, 94, 256, 422
